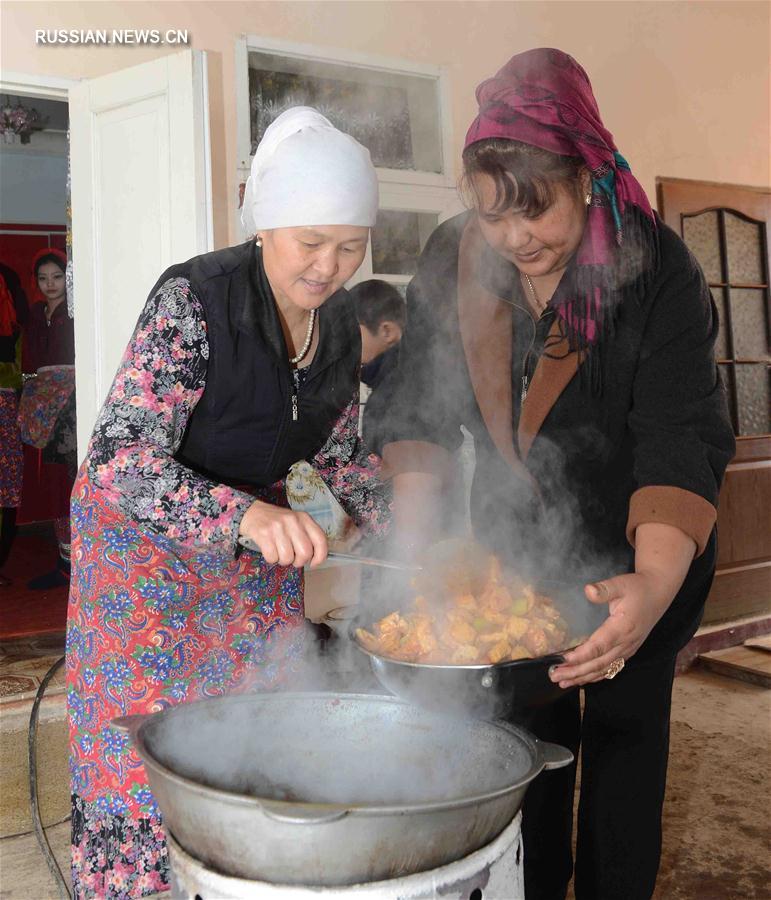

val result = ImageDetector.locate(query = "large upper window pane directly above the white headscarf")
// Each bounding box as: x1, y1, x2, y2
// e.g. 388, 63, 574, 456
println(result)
249, 52, 443, 172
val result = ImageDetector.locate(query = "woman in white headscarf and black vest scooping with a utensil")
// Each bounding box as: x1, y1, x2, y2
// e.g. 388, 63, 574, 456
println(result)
67, 108, 389, 898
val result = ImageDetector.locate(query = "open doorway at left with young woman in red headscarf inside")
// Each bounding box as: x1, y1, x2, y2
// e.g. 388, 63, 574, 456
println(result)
0, 76, 77, 640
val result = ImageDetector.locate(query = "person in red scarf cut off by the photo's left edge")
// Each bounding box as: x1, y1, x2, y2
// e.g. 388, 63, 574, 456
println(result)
0, 263, 27, 587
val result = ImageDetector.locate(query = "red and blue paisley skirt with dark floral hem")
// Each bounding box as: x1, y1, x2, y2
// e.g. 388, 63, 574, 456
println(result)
67, 472, 304, 900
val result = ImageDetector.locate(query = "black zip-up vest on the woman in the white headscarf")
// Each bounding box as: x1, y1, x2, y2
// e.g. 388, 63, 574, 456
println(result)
151, 241, 361, 487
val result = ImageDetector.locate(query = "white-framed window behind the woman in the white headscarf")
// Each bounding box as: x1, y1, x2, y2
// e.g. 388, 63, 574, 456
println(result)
236, 36, 462, 289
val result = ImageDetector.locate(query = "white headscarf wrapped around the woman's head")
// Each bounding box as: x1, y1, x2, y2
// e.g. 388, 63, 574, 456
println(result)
241, 106, 378, 235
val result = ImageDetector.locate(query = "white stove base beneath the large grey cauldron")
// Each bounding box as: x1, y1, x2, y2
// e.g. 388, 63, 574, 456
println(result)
168, 813, 525, 900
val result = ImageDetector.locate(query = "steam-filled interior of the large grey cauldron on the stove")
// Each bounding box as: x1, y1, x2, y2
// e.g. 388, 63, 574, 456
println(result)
146, 695, 534, 806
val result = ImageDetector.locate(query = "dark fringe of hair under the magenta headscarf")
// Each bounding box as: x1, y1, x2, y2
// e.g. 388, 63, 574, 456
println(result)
461, 138, 586, 216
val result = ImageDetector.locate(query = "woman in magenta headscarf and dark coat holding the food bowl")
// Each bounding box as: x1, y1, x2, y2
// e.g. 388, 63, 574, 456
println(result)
384, 49, 734, 900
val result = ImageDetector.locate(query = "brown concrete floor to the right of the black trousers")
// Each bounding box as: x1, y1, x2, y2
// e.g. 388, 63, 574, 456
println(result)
655, 669, 771, 900
